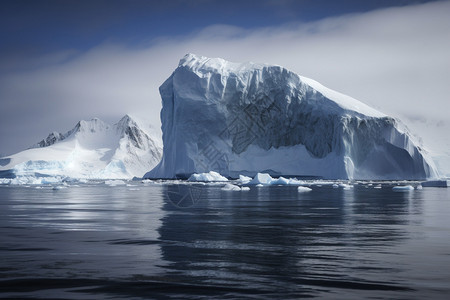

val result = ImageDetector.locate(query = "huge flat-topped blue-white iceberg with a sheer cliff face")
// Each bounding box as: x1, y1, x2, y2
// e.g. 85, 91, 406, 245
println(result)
145, 54, 436, 179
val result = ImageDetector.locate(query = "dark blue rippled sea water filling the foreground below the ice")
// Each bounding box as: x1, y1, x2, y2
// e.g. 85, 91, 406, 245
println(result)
0, 183, 450, 299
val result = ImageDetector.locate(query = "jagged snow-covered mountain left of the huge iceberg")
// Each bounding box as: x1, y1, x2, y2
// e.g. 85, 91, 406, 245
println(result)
0, 115, 162, 178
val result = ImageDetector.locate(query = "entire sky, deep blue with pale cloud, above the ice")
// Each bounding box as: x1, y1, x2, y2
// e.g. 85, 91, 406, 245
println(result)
0, 0, 450, 173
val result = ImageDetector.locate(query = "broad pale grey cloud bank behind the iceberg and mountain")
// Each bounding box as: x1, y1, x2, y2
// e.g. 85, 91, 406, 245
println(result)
0, 1, 450, 159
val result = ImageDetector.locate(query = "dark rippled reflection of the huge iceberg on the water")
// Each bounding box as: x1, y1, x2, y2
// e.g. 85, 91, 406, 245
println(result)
158, 186, 416, 295
